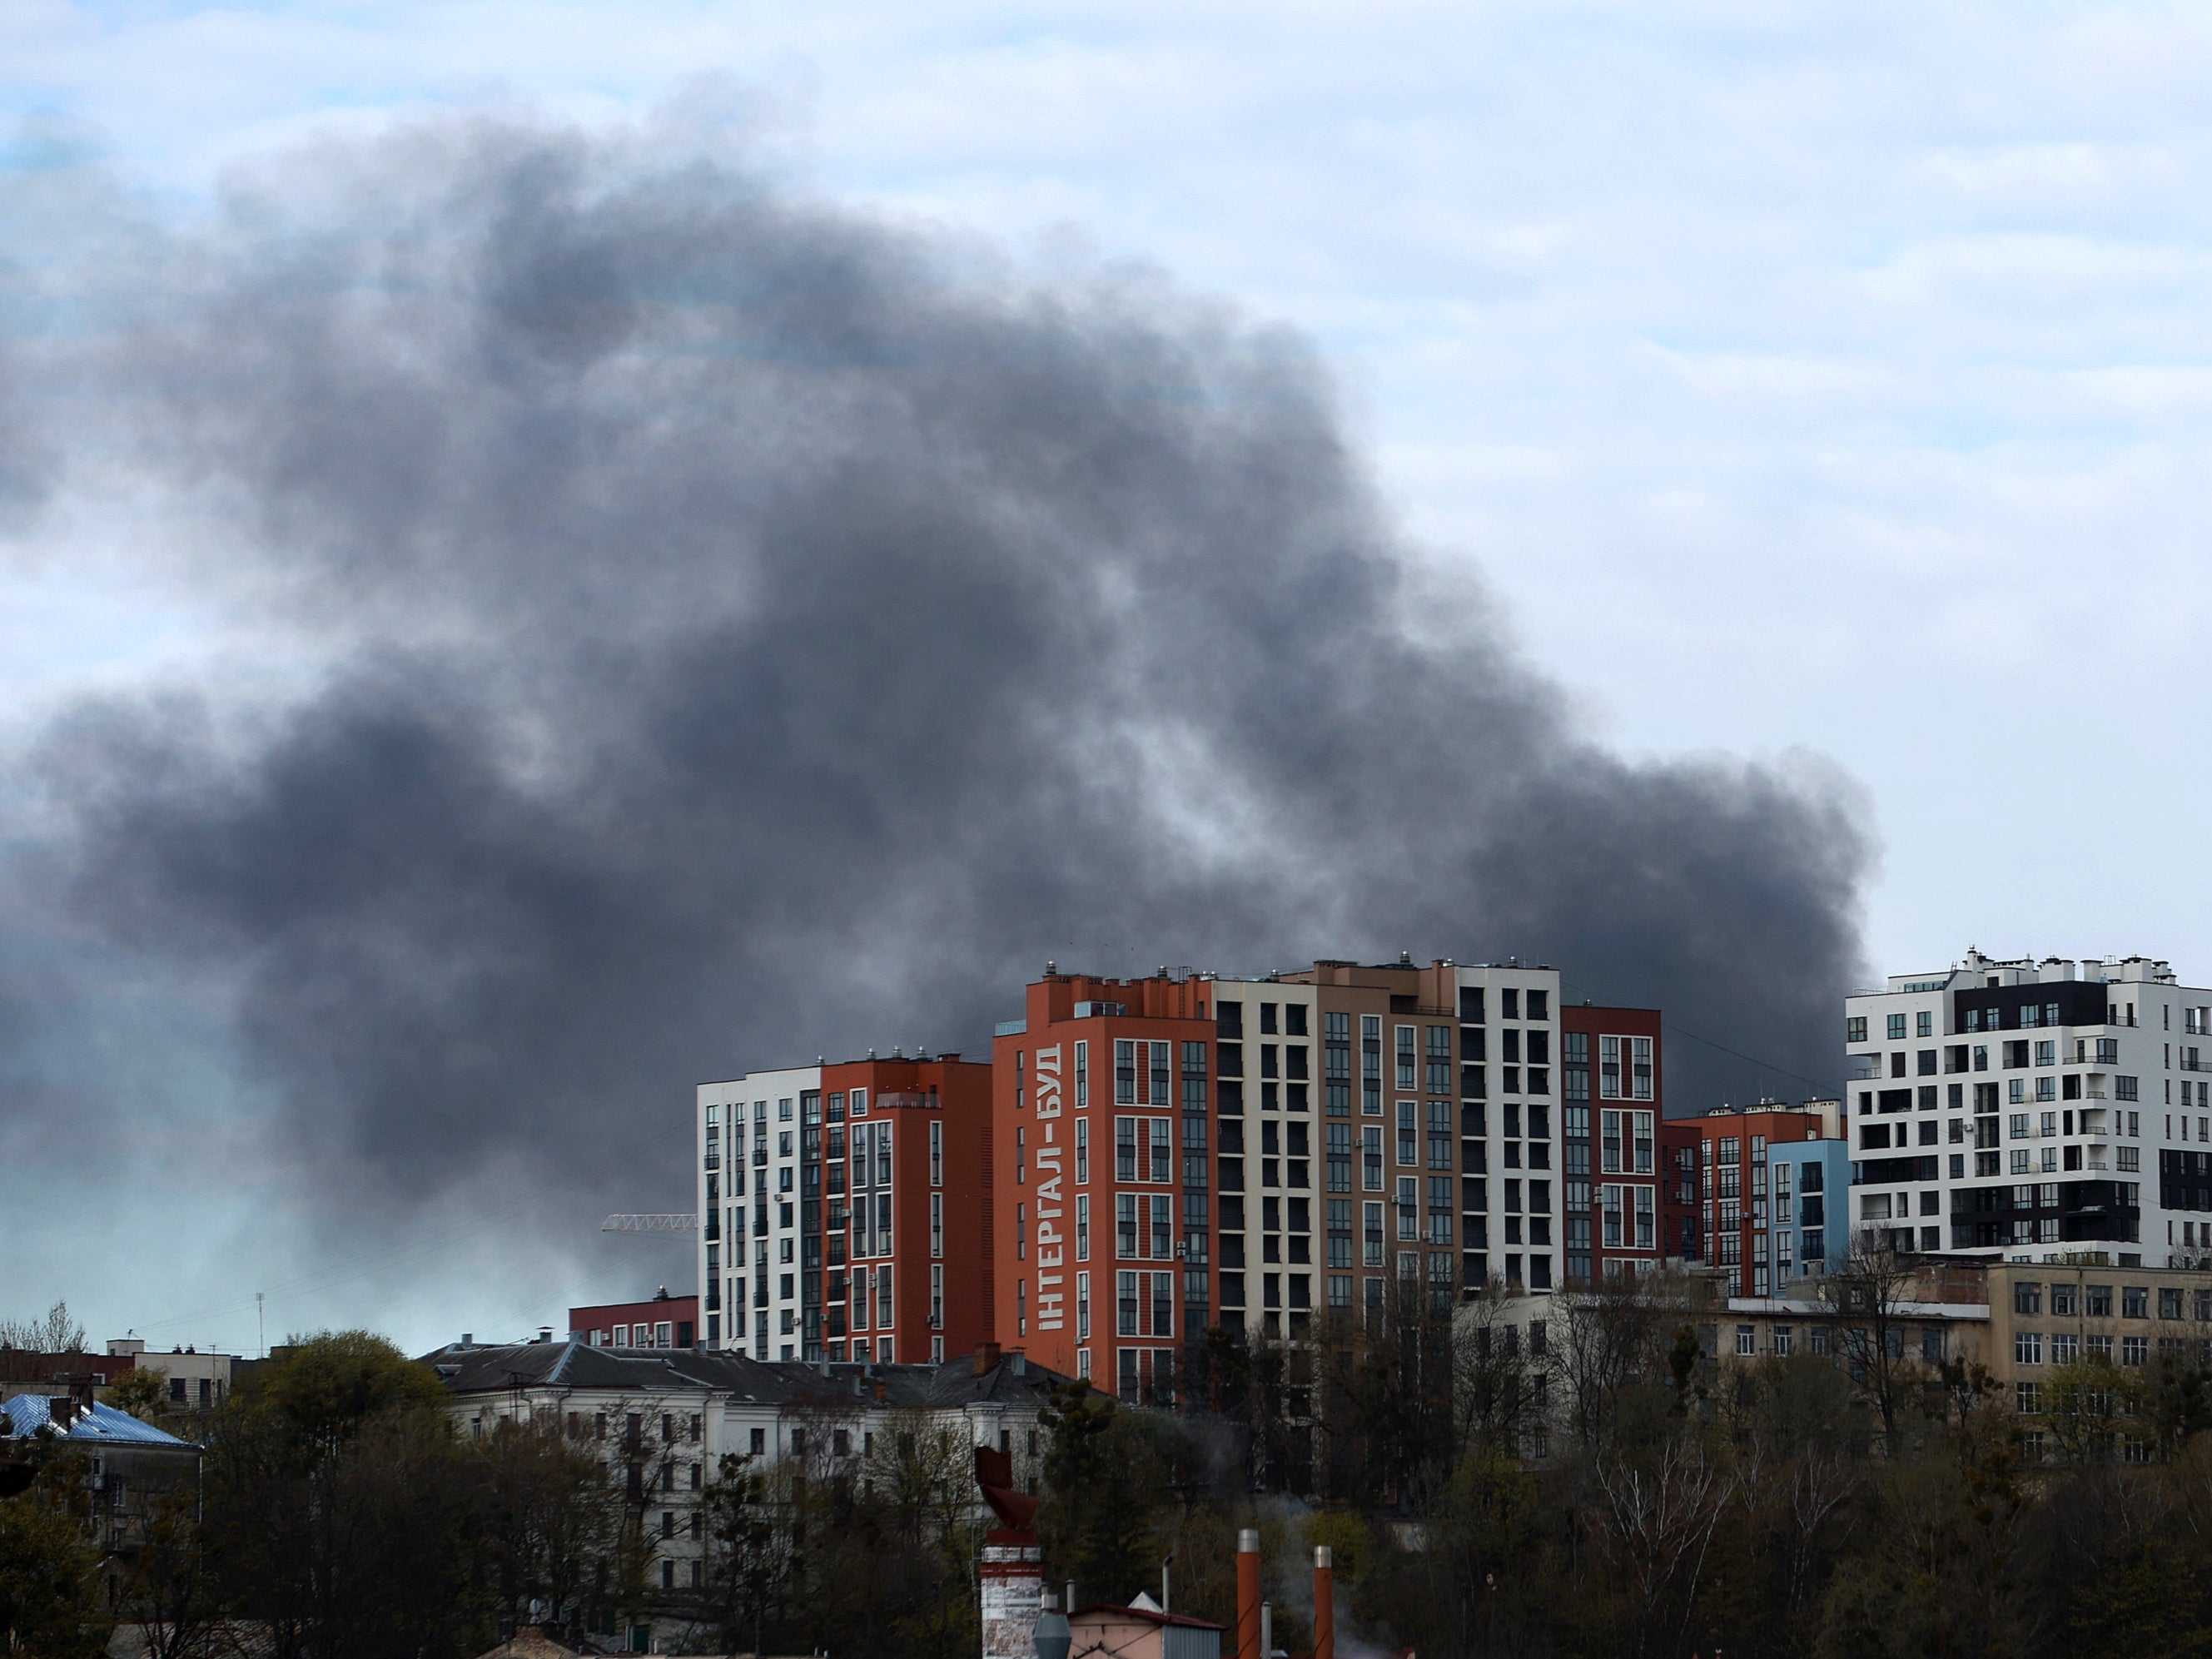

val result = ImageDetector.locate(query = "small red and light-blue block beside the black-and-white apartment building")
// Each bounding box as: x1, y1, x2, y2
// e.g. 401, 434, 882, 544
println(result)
1659, 1100, 1852, 1296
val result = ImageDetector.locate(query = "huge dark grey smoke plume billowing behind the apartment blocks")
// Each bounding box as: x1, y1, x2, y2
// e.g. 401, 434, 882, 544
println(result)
4, 113, 1869, 1239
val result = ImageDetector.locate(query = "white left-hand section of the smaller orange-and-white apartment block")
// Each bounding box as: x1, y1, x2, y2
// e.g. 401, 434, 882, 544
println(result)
697, 1064, 823, 1360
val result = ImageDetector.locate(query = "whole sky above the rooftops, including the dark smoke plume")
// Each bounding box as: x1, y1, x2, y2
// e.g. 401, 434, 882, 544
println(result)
0, 4, 2212, 1352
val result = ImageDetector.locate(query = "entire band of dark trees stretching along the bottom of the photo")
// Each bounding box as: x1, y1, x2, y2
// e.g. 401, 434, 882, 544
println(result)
12, 1281, 2212, 1659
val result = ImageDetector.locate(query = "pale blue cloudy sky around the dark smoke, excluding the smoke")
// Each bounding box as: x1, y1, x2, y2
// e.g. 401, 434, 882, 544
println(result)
0, 0, 2212, 1347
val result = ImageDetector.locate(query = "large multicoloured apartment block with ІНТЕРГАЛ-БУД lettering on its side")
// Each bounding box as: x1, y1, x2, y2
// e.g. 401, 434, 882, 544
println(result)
993, 960, 1661, 1398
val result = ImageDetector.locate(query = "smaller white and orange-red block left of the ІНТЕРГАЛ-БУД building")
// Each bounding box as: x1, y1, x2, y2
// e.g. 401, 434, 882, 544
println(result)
697, 1053, 993, 1365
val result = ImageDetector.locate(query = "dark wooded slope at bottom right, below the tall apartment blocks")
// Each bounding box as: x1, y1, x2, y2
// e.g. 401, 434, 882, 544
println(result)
1044, 1263, 2212, 1659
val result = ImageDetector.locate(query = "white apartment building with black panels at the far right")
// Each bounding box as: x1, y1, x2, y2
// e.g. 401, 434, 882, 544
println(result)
1845, 951, 2212, 1268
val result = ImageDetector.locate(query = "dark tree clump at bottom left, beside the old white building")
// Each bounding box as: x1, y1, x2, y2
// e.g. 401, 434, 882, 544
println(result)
0, 1332, 650, 1659
